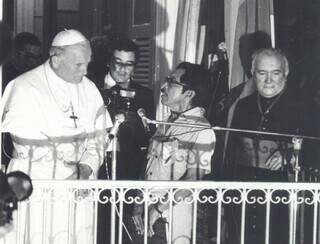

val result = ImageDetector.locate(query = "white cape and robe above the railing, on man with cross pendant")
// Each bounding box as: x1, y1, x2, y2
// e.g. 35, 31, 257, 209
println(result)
2, 62, 109, 179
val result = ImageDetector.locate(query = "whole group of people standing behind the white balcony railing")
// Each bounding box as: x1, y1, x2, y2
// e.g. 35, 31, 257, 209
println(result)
1, 29, 318, 244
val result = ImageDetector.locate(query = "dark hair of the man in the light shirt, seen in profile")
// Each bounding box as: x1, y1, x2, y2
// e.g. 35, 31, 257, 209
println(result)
177, 62, 211, 109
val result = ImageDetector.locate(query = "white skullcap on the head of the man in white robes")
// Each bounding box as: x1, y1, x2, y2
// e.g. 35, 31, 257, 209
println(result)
51, 29, 87, 47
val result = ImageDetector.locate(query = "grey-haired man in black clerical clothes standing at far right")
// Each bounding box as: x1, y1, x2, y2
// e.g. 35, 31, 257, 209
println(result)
226, 48, 303, 244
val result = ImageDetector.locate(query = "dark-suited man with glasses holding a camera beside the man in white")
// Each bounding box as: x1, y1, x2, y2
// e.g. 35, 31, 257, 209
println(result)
100, 37, 155, 180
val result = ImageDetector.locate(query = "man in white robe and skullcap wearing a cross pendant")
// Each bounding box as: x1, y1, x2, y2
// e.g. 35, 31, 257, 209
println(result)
1, 30, 111, 244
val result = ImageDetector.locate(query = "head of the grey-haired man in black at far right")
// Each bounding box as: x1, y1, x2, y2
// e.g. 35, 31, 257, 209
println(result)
251, 48, 289, 98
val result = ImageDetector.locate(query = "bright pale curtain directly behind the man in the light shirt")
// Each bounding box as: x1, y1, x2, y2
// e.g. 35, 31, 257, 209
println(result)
154, 0, 205, 119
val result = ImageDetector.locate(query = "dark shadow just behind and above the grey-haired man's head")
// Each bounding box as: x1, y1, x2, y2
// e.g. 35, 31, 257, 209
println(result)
239, 31, 271, 78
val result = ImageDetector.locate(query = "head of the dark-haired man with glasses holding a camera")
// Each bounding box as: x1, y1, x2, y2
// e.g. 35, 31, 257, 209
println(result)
110, 37, 138, 88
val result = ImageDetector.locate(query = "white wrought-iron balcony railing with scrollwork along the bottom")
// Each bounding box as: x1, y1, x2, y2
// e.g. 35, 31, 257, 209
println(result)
0, 180, 320, 244
